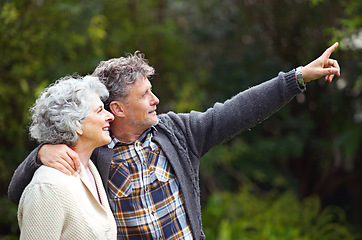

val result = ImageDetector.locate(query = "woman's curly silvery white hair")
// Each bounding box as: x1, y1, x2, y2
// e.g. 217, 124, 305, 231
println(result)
29, 76, 109, 146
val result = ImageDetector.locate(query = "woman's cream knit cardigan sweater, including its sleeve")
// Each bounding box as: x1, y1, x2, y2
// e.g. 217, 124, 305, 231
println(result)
18, 161, 117, 240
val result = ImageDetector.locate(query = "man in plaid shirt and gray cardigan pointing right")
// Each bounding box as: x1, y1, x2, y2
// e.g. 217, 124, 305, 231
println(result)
9, 43, 340, 239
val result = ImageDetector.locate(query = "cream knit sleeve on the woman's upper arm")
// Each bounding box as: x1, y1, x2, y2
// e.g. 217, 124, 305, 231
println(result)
18, 184, 65, 240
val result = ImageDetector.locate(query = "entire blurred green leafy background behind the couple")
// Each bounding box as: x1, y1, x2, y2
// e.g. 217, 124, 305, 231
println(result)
0, 0, 362, 240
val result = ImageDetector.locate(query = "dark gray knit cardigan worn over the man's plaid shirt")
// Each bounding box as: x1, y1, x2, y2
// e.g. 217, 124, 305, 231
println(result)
8, 70, 305, 239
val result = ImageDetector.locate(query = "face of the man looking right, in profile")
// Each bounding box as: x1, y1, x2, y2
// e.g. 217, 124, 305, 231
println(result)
124, 78, 159, 132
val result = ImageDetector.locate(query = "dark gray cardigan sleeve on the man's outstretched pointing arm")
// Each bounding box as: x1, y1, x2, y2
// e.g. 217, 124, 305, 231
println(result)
170, 70, 305, 158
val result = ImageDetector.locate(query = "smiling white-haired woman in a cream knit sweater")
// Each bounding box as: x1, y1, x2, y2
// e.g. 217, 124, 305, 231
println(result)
18, 76, 117, 239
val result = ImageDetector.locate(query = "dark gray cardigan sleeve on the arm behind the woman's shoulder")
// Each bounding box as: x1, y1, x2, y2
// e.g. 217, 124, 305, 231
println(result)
8, 145, 42, 204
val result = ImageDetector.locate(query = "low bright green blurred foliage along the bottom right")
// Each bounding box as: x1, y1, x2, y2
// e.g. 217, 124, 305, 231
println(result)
202, 187, 361, 240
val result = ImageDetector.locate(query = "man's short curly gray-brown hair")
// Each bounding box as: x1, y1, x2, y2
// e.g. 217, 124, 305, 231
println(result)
92, 51, 155, 109
